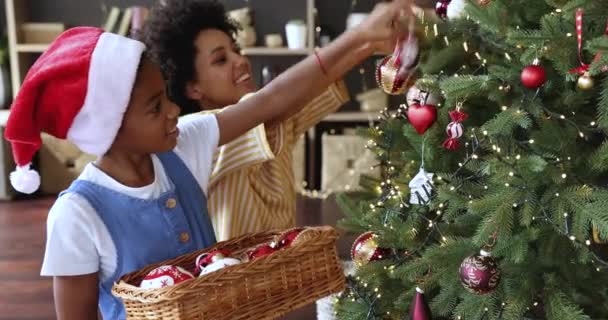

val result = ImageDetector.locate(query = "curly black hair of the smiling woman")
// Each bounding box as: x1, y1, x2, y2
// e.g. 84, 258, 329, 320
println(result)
141, 0, 239, 114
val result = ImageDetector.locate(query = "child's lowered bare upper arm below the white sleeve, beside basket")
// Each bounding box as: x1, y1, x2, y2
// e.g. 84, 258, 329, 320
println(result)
53, 273, 99, 320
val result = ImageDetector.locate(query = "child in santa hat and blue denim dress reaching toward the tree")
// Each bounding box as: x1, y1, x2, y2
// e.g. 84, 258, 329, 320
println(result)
6, 0, 409, 320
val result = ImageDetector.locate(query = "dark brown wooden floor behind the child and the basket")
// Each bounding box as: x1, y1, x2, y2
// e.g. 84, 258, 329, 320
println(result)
0, 197, 352, 320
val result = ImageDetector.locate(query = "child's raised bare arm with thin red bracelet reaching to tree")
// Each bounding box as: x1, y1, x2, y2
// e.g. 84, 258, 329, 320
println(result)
217, 0, 411, 145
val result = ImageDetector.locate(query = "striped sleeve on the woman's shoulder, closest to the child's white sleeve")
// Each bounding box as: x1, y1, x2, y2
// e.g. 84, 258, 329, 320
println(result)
210, 124, 274, 188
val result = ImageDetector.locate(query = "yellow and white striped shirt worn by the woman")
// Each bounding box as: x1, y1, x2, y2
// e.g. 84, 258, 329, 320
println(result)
208, 82, 349, 241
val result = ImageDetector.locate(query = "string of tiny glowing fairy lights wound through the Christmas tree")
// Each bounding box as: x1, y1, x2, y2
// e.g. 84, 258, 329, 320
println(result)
335, 4, 608, 319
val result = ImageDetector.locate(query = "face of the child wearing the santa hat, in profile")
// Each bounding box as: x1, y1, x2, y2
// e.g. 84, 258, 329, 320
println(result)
112, 58, 180, 154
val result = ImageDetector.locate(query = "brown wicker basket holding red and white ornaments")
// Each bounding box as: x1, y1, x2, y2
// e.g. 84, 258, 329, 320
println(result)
112, 227, 345, 320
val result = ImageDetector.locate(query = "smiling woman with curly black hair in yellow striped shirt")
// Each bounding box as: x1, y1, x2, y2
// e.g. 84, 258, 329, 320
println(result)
143, 0, 406, 240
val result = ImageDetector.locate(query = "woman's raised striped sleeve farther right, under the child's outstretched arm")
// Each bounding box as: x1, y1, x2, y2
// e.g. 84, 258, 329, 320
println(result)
290, 80, 350, 137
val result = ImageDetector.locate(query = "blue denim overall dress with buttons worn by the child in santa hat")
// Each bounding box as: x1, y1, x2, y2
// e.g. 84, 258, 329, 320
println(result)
62, 152, 216, 320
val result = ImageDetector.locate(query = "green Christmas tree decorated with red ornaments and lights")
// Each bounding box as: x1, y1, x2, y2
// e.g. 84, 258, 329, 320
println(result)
335, 0, 608, 320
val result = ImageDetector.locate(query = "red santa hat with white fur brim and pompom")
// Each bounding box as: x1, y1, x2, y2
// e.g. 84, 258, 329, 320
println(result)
5, 27, 145, 193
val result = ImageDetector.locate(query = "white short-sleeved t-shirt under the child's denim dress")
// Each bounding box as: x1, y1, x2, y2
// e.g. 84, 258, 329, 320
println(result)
41, 114, 219, 281
